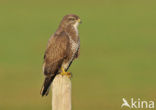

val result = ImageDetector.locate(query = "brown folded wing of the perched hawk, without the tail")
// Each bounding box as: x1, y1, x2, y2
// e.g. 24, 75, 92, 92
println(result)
44, 32, 69, 76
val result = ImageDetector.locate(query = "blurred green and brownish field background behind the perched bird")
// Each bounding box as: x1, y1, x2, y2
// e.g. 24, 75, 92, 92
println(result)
0, 0, 156, 110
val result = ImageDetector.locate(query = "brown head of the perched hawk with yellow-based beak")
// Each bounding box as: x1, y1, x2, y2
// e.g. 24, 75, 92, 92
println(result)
61, 14, 81, 28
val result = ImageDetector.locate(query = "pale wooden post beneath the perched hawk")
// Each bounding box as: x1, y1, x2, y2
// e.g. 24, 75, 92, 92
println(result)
52, 74, 71, 110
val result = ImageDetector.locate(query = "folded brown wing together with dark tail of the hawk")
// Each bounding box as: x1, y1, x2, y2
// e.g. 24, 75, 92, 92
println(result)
40, 32, 70, 96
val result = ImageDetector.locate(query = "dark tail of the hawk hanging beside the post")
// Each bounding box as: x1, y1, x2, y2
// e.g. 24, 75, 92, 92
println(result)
40, 75, 56, 96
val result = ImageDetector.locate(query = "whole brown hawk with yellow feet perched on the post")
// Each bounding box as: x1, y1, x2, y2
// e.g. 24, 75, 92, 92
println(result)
41, 14, 81, 96
